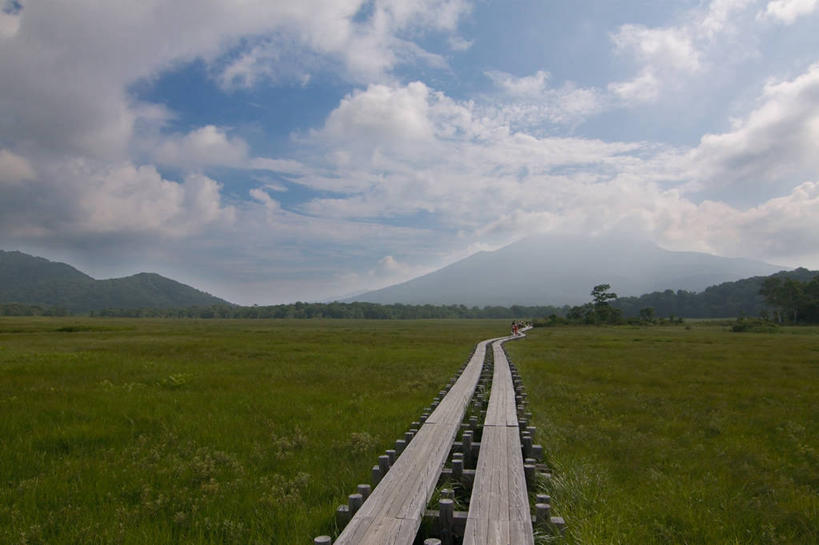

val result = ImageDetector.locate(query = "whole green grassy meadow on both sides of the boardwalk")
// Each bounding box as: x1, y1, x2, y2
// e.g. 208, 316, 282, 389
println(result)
0, 318, 819, 545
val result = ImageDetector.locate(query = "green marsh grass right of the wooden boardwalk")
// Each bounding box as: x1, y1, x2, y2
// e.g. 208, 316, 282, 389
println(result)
507, 323, 819, 545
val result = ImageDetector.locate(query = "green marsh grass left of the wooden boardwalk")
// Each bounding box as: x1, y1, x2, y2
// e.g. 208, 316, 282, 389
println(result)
0, 318, 507, 545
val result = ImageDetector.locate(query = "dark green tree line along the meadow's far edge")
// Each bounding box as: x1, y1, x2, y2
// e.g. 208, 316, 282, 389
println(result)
0, 268, 819, 325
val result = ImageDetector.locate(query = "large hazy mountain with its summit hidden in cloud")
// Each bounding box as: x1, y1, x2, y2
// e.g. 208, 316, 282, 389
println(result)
351, 235, 782, 306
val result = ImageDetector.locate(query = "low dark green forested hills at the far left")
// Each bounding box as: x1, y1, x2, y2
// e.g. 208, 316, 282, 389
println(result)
0, 250, 230, 312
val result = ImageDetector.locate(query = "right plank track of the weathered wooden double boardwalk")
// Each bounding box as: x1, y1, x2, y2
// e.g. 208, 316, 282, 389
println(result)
463, 341, 534, 545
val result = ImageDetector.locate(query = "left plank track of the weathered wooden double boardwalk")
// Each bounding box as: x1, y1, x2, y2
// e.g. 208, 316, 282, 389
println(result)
335, 339, 500, 545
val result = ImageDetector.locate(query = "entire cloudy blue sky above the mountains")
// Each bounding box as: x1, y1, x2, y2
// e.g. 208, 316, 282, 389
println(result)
0, 0, 819, 304
